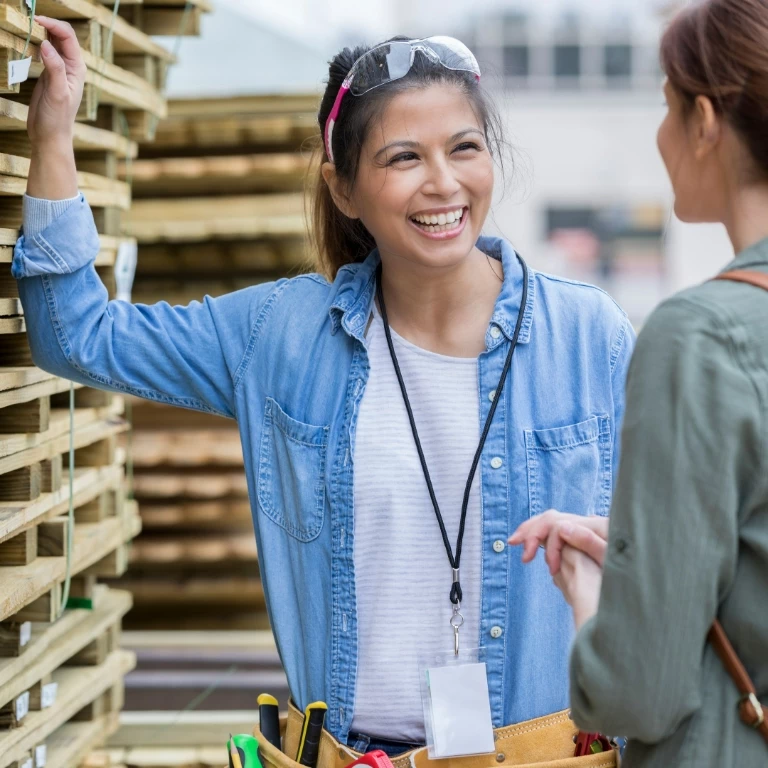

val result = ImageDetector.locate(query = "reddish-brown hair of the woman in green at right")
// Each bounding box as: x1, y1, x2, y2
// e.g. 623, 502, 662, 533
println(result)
661, 0, 768, 179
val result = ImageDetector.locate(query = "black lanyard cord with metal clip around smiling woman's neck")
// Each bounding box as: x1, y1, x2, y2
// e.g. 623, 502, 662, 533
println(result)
376, 254, 528, 656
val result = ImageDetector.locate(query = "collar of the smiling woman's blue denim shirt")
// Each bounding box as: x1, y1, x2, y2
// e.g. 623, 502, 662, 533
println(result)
330, 237, 536, 350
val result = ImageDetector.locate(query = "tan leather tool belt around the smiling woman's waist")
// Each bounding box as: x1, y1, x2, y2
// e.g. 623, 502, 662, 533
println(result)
253, 704, 619, 768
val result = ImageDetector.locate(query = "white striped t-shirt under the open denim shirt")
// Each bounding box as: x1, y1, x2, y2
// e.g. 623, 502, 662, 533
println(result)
352, 310, 481, 743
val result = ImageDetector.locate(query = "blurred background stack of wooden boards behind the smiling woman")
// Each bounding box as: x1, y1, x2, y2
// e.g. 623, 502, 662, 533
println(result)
114, 96, 317, 630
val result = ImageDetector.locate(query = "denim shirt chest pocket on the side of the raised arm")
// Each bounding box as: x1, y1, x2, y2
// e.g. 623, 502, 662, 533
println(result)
258, 397, 329, 542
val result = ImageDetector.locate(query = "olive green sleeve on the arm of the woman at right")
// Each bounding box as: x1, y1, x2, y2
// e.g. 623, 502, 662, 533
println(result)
571, 298, 761, 743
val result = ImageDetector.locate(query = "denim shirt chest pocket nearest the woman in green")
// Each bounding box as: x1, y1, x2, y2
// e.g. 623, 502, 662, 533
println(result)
525, 416, 613, 517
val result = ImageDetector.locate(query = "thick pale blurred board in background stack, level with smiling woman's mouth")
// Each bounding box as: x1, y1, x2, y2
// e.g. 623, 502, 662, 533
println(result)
131, 193, 305, 243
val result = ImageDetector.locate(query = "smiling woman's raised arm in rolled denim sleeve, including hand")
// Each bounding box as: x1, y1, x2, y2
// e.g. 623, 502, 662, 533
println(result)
12, 17, 280, 416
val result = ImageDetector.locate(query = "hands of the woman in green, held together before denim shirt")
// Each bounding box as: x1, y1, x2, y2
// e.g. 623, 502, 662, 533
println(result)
509, 509, 608, 629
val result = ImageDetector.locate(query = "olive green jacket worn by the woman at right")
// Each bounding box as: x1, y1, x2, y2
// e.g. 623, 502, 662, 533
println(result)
571, 239, 768, 768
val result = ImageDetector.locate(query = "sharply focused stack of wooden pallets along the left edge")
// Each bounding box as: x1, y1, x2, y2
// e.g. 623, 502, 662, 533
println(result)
0, 0, 206, 768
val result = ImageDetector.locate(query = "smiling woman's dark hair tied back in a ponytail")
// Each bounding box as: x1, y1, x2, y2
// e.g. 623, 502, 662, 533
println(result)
309, 37, 504, 280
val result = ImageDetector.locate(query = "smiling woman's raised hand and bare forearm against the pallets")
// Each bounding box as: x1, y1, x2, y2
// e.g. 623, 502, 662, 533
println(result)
27, 16, 86, 200
